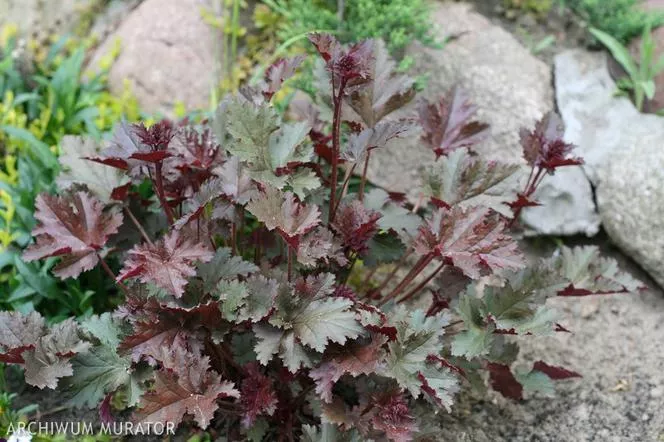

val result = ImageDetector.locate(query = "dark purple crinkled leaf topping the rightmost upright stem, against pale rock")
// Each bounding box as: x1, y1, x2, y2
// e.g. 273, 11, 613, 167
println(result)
520, 112, 583, 174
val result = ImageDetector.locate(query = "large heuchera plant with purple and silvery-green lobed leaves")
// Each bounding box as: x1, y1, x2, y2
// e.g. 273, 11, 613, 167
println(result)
0, 34, 640, 441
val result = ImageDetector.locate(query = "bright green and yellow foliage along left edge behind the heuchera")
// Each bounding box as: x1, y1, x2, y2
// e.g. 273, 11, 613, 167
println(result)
0, 27, 138, 319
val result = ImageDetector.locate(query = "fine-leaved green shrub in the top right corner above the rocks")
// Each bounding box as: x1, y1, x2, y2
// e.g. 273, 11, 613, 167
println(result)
565, 0, 664, 44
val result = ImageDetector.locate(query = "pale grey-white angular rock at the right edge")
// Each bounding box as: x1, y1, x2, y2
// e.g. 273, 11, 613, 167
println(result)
549, 50, 664, 284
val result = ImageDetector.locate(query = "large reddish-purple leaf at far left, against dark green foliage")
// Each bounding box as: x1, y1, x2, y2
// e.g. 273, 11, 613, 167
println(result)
23, 192, 122, 279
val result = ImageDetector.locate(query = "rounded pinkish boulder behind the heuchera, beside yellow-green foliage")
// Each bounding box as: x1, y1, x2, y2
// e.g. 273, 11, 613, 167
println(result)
91, 0, 215, 114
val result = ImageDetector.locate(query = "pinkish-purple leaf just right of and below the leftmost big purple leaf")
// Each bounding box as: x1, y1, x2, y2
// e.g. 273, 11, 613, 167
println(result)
118, 230, 214, 297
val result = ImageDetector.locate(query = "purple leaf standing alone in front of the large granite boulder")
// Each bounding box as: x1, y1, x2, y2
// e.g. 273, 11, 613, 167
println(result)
418, 88, 489, 157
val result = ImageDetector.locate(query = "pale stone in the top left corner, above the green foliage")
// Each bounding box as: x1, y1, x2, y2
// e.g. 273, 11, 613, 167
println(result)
0, 0, 96, 40
